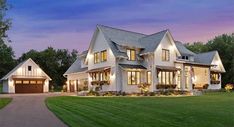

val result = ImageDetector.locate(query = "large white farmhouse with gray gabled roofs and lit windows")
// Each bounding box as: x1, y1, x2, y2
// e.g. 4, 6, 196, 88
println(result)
64, 25, 225, 93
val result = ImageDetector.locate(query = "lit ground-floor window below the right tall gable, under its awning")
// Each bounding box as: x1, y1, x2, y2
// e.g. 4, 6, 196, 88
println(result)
158, 71, 174, 85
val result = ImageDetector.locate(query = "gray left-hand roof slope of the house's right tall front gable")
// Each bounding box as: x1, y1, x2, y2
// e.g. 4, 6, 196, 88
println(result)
139, 30, 168, 54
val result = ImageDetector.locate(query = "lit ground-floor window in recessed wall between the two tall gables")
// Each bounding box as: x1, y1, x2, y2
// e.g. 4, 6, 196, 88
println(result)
128, 71, 140, 85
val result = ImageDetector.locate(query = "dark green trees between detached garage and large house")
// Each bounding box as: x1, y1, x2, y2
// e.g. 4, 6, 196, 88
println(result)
18, 47, 78, 86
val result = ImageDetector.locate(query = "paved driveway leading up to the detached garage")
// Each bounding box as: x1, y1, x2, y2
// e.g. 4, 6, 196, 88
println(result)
0, 94, 71, 127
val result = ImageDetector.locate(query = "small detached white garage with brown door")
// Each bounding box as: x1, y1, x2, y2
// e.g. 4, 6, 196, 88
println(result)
1, 58, 51, 93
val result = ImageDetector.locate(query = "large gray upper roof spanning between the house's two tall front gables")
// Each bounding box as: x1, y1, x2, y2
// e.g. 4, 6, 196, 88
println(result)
97, 25, 168, 57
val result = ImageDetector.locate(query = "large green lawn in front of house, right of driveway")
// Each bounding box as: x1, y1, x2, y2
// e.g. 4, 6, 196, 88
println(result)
46, 93, 234, 127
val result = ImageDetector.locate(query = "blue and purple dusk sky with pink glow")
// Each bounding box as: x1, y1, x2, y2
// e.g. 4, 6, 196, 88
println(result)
7, 0, 234, 57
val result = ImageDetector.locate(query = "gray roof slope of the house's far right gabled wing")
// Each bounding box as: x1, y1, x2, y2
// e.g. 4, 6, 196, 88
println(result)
194, 51, 217, 64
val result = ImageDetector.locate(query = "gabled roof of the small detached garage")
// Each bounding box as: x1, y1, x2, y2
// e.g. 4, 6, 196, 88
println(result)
1, 58, 52, 80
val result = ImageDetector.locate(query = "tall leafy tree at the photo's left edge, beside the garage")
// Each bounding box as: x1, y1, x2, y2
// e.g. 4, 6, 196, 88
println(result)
0, 0, 16, 77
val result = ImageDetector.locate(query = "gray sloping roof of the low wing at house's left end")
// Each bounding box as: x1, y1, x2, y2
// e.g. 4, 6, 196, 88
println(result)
63, 57, 88, 75
